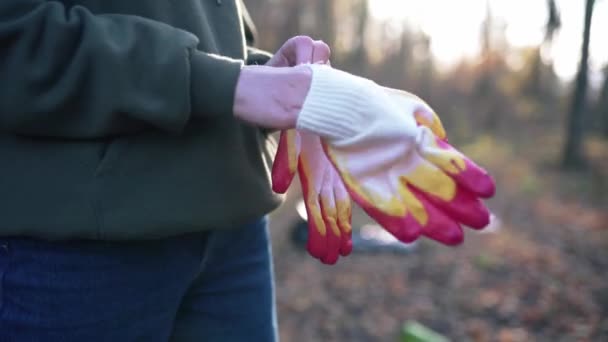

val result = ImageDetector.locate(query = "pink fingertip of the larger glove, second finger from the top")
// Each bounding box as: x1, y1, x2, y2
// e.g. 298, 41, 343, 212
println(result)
426, 185, 490, 229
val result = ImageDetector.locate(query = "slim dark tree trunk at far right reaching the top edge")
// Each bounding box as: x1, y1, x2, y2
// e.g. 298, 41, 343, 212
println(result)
562, 0, 594, 168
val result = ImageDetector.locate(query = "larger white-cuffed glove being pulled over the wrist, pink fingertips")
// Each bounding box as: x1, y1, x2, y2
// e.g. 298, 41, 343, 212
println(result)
297, 65, 495, 245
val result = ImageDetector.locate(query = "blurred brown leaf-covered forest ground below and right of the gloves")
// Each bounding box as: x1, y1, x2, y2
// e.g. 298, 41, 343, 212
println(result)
271, 137, 608, 342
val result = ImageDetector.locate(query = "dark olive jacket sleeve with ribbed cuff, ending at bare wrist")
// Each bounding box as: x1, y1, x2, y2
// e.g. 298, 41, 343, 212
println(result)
0, 0, 242, 138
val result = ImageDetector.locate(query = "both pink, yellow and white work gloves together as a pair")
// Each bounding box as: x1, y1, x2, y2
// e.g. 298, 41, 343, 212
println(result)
272, 64, 495, 264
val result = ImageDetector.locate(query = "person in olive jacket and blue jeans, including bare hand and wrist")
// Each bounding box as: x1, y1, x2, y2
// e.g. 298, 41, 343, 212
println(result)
0, 0, 330, 341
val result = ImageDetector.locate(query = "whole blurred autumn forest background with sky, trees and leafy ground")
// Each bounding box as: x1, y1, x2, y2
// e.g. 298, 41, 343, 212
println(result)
245, 0, 608, 341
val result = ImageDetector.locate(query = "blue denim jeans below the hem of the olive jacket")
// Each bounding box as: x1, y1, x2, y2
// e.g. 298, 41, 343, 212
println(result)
0, 219, 277, 342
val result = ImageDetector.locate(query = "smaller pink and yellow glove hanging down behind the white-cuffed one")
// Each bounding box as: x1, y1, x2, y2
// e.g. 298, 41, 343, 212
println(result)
272, 129, 352, 264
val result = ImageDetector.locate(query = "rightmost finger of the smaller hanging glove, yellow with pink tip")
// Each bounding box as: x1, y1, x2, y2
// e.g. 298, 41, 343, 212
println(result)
330, 171, 353, 256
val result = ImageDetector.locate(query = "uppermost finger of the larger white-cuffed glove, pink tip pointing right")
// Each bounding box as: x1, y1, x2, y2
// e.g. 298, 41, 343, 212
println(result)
421, 137, 496, 198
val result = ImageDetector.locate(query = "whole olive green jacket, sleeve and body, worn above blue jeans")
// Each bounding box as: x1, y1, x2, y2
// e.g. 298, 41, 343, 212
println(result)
0, 0, 280, 240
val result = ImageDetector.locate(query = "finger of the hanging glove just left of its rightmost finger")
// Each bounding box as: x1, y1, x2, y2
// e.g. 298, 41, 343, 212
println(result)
319, 183, 341, 265
